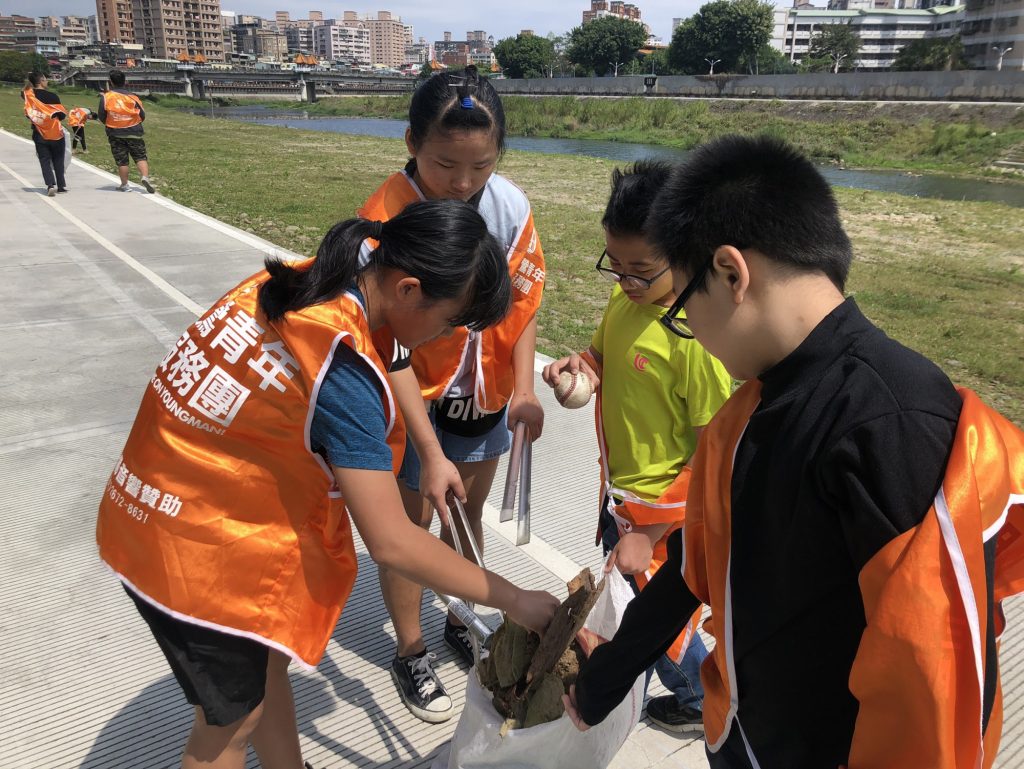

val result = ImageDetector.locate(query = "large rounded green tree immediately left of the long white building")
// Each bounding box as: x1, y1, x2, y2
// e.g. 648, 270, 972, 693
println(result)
669, 0, 774, 75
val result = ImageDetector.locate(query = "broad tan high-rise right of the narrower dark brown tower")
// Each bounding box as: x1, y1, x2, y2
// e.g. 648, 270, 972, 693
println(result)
130, 0, 224, 61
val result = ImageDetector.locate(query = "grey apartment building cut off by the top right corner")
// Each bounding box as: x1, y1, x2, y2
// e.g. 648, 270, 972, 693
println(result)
961, 0, 1024, 72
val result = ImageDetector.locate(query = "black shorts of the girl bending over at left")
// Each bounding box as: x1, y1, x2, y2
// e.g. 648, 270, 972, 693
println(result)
125, 586, 269, 726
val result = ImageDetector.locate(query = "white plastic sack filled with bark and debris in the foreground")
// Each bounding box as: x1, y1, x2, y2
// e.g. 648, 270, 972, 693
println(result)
431, 569, 644, 769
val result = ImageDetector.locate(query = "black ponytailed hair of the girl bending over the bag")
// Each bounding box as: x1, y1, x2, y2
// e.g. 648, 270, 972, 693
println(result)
259, 200, 512, 331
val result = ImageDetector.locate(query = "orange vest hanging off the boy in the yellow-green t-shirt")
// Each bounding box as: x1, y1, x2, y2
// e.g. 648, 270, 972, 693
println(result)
582, 350, 700, 665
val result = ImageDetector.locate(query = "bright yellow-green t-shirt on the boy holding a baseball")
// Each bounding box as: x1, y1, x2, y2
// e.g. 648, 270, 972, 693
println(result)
591, 286, 732, 501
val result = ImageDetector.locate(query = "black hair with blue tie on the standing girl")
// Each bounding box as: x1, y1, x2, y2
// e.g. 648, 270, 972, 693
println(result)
409, 65, 505, 155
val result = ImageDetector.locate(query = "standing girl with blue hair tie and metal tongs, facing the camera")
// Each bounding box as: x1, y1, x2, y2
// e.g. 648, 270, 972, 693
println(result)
359, 67, 545, 722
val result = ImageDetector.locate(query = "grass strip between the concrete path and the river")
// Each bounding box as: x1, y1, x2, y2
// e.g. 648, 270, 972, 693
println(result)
0, 88, 1024, 425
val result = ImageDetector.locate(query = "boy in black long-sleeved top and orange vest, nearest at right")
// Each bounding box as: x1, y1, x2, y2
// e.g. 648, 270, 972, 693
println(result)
566, 136, 1024, 769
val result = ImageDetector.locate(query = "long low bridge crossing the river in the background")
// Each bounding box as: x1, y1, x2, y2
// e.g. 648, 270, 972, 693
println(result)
74, 65, 416, 101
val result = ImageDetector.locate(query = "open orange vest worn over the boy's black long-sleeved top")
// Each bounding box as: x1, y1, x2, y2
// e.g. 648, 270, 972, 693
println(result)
683, 380, 1024, 769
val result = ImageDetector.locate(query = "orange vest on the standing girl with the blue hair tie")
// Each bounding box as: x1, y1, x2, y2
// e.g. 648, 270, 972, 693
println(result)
358, 171, 545, 414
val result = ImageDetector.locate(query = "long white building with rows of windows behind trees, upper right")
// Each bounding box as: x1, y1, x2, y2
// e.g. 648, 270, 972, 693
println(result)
772, 5, 965, 71
